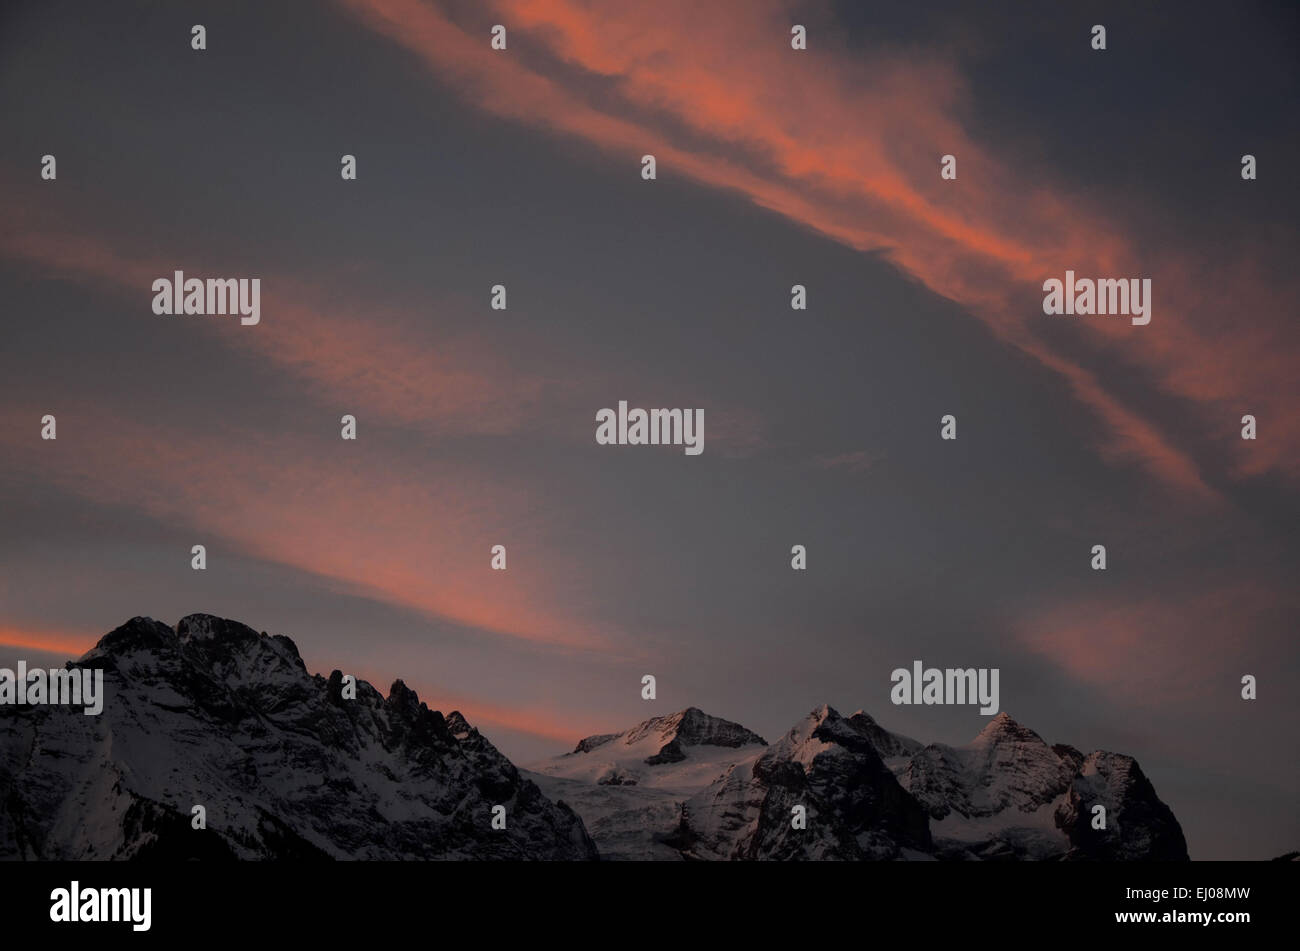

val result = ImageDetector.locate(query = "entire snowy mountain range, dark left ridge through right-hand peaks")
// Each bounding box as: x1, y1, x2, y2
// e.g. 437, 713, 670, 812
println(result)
0, 615, 1187, 861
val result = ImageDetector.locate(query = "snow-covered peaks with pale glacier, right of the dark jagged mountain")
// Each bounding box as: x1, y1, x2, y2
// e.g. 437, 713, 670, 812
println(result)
534, 707, 1187, 861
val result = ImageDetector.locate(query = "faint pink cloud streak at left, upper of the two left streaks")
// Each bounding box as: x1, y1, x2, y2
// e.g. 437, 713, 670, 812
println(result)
0, 180, 767, 455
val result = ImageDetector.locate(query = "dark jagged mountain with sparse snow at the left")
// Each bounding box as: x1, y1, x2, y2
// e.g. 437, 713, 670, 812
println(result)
0, 615, 597, 859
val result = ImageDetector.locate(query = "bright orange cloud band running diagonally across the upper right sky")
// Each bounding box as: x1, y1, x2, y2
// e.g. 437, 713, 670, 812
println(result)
341, 0, 1300, 500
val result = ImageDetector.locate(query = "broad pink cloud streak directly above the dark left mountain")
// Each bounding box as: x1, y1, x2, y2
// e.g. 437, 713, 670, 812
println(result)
0, 405, 611, 650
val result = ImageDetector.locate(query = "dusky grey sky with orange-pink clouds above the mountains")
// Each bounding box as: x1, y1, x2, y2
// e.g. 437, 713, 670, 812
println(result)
0, 0, 1300, 859
